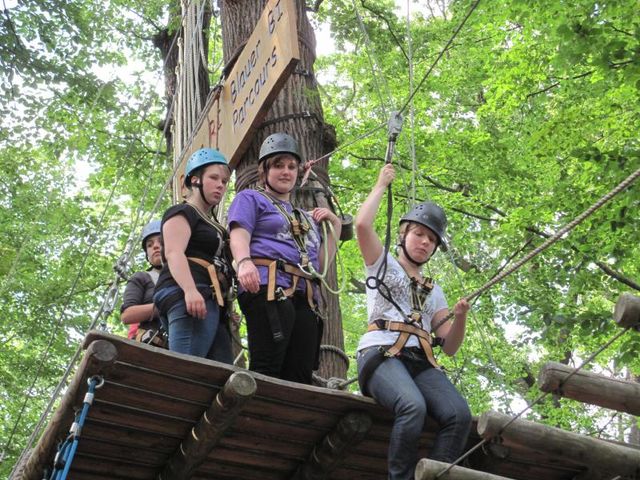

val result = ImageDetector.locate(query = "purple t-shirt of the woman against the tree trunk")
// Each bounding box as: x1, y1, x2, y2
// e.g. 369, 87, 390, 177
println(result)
227, 190, 321, 290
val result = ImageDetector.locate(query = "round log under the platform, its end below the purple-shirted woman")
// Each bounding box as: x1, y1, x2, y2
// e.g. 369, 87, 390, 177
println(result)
159, 372, 257, 480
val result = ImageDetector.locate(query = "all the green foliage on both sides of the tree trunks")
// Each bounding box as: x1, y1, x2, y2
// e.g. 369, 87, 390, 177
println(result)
0, 0, 640, 477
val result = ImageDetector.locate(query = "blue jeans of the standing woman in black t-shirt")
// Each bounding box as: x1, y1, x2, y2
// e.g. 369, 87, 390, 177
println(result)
156, 289, 233, 364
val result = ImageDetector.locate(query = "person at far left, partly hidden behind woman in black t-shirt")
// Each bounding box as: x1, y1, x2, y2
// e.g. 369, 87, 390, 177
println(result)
120, 220, 166, 347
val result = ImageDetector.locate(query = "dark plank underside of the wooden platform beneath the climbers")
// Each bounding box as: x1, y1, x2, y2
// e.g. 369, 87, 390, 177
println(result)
14, 332, 604, 480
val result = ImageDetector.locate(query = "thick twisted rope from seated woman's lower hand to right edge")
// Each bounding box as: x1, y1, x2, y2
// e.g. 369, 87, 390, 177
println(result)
433, 169, 640, 333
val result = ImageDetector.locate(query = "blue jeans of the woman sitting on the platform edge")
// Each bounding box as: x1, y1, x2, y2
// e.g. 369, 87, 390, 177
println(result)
358, 348, 471, 480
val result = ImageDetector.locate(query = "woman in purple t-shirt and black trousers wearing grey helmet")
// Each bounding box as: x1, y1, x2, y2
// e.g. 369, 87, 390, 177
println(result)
228, 133, 341, 384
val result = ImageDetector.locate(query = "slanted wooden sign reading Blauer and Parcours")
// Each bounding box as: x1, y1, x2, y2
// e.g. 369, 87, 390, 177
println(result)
174, 0, 300, 192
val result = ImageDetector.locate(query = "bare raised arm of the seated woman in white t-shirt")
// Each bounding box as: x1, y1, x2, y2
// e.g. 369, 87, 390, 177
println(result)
355, 164, 396, 265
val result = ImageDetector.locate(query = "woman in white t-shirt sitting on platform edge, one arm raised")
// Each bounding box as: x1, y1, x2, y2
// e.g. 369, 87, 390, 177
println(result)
355, 164, 471, 480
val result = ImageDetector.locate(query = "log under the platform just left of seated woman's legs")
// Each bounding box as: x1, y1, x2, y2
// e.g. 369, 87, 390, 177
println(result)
292, 412, 373, 480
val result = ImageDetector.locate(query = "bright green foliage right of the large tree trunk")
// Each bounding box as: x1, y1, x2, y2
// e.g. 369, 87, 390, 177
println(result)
316, 0, 640, 442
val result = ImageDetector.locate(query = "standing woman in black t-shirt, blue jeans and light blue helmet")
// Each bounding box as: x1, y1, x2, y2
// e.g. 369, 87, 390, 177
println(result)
154, 148, 233, 363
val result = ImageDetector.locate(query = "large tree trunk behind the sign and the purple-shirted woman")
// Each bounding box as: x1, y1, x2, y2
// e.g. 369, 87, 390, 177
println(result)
218, 0, 346, 378
